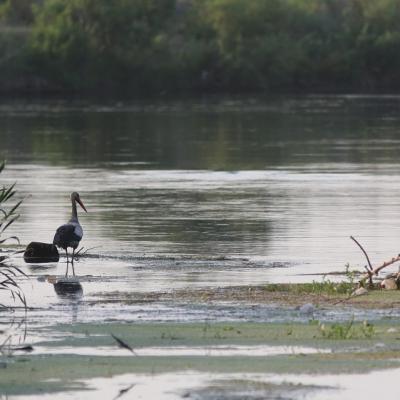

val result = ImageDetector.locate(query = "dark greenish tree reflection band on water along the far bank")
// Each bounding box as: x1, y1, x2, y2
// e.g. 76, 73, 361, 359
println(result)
0, 96, 400, 171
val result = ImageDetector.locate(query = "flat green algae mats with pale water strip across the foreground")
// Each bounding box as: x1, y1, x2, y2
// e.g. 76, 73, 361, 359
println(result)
0, 320, 400, 398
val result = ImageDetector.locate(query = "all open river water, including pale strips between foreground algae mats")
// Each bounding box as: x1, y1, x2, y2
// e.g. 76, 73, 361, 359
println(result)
0, 95, 400, 399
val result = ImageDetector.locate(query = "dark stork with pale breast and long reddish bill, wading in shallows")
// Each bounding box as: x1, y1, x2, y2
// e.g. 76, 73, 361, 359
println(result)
53, 192, 87, 276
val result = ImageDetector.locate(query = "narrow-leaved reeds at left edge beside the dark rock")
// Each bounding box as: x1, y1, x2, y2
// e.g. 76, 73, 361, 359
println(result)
0, 161, 26, 308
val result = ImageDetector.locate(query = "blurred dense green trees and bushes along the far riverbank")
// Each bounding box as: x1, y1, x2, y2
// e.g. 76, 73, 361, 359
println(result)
0, 0, 400, 93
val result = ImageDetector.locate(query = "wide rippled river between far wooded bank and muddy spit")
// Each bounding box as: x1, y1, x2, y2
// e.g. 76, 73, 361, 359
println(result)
0, 95, 400, 316
